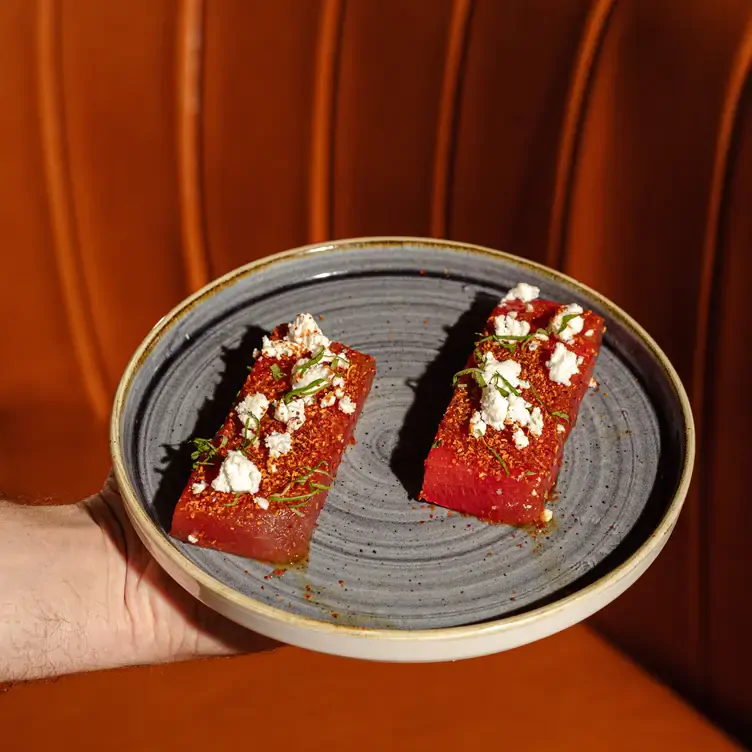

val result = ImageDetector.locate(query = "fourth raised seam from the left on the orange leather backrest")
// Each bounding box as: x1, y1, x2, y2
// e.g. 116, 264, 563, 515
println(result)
430, 0, 474, 238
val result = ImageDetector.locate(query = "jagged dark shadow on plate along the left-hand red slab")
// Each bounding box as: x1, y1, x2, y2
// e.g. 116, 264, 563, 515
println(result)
149, 326, 268, 532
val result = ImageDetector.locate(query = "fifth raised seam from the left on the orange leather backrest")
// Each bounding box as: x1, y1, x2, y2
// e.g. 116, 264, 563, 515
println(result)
546, 0, 616, 268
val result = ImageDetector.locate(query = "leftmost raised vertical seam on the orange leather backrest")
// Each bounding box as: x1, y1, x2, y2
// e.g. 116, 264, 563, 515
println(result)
37, 0, 110, 420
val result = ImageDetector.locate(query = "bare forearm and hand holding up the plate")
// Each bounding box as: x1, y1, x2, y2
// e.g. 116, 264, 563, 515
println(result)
0, 481, 275, 682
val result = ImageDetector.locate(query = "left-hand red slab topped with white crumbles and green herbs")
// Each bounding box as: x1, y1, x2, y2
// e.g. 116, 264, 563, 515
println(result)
171, 314, 376, 563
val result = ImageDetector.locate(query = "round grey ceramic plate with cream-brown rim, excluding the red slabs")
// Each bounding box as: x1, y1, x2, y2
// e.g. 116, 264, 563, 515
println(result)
112, 239, 694, 660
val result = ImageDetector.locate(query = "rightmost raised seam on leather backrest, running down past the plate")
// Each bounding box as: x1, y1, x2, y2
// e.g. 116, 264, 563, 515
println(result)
690, 19, 752, 692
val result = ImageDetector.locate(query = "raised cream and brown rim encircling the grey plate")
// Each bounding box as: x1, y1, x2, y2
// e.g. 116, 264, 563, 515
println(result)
110, 236, 696, 643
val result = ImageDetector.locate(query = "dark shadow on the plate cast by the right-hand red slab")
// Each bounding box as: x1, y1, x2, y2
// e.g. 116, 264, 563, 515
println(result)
390, 292, 499, 499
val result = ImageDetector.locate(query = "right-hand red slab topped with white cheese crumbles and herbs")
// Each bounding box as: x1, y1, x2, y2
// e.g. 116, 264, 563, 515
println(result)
420, 283, 605, 524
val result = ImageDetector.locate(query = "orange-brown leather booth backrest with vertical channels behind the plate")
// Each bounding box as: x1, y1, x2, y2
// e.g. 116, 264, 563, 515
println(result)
0, 0, 752, 738
